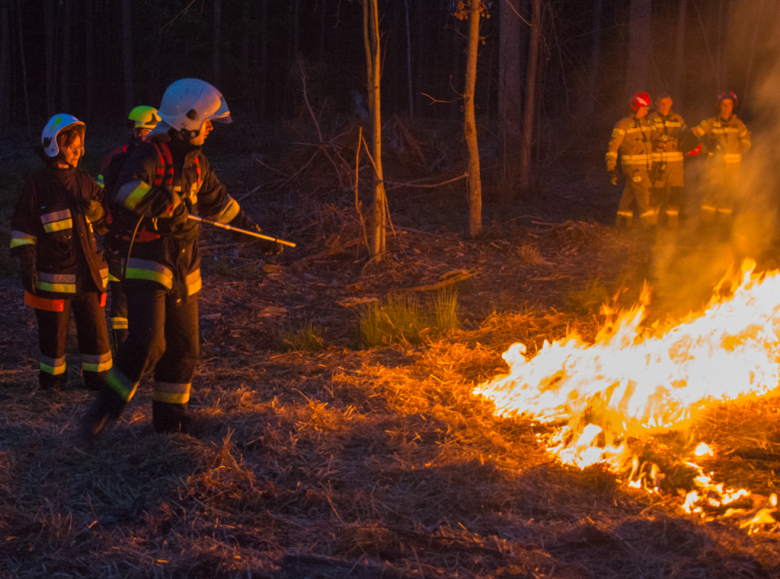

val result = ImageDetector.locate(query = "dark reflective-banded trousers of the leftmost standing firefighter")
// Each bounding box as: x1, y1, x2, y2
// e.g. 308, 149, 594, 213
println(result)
35, 292, 112, 390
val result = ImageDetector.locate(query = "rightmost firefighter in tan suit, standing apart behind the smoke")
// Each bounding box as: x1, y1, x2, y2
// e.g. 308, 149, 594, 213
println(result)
692, 91, 751, 225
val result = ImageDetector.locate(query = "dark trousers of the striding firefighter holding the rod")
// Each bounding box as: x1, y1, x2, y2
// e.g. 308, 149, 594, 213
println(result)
106, 279, 198, 432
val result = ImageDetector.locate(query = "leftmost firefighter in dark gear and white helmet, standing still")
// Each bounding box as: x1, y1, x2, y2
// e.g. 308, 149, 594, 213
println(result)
11, 114, 112, 390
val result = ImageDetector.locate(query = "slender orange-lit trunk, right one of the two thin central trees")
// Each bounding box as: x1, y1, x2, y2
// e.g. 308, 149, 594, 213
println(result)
463, 0, 482, 237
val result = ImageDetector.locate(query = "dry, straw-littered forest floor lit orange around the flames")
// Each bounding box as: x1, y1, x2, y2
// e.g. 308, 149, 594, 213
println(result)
0, 124, 780, 579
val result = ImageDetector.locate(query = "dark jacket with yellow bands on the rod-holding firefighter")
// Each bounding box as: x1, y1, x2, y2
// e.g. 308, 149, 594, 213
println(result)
107, 132, 247, 298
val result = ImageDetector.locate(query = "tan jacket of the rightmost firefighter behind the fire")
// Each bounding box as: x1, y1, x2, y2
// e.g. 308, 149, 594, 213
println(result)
693, 115, 751, 186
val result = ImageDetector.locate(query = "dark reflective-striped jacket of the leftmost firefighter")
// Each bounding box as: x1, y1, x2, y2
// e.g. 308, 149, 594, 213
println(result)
11, 164, 108, 308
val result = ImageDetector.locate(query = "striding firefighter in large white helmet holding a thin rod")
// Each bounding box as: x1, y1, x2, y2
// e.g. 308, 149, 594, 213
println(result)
81, 78, 275, 437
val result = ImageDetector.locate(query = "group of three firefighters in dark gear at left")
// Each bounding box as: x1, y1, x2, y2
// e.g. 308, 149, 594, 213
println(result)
11, 79, 280, 437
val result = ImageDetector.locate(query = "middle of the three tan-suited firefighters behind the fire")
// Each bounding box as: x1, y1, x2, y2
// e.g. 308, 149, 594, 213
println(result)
648, 93, 685, 230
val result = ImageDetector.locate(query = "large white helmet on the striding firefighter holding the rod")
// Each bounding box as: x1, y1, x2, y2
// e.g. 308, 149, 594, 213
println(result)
157, 78, 233, 138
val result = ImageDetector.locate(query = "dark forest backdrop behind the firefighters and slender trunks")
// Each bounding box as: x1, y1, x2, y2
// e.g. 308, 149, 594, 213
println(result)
0, 0, 778, 186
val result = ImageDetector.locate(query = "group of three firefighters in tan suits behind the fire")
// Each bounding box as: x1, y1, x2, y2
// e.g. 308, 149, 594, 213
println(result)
606, 92, 751, 230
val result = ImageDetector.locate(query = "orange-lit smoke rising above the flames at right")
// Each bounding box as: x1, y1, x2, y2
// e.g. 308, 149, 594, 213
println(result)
653, 0, 780, 313
